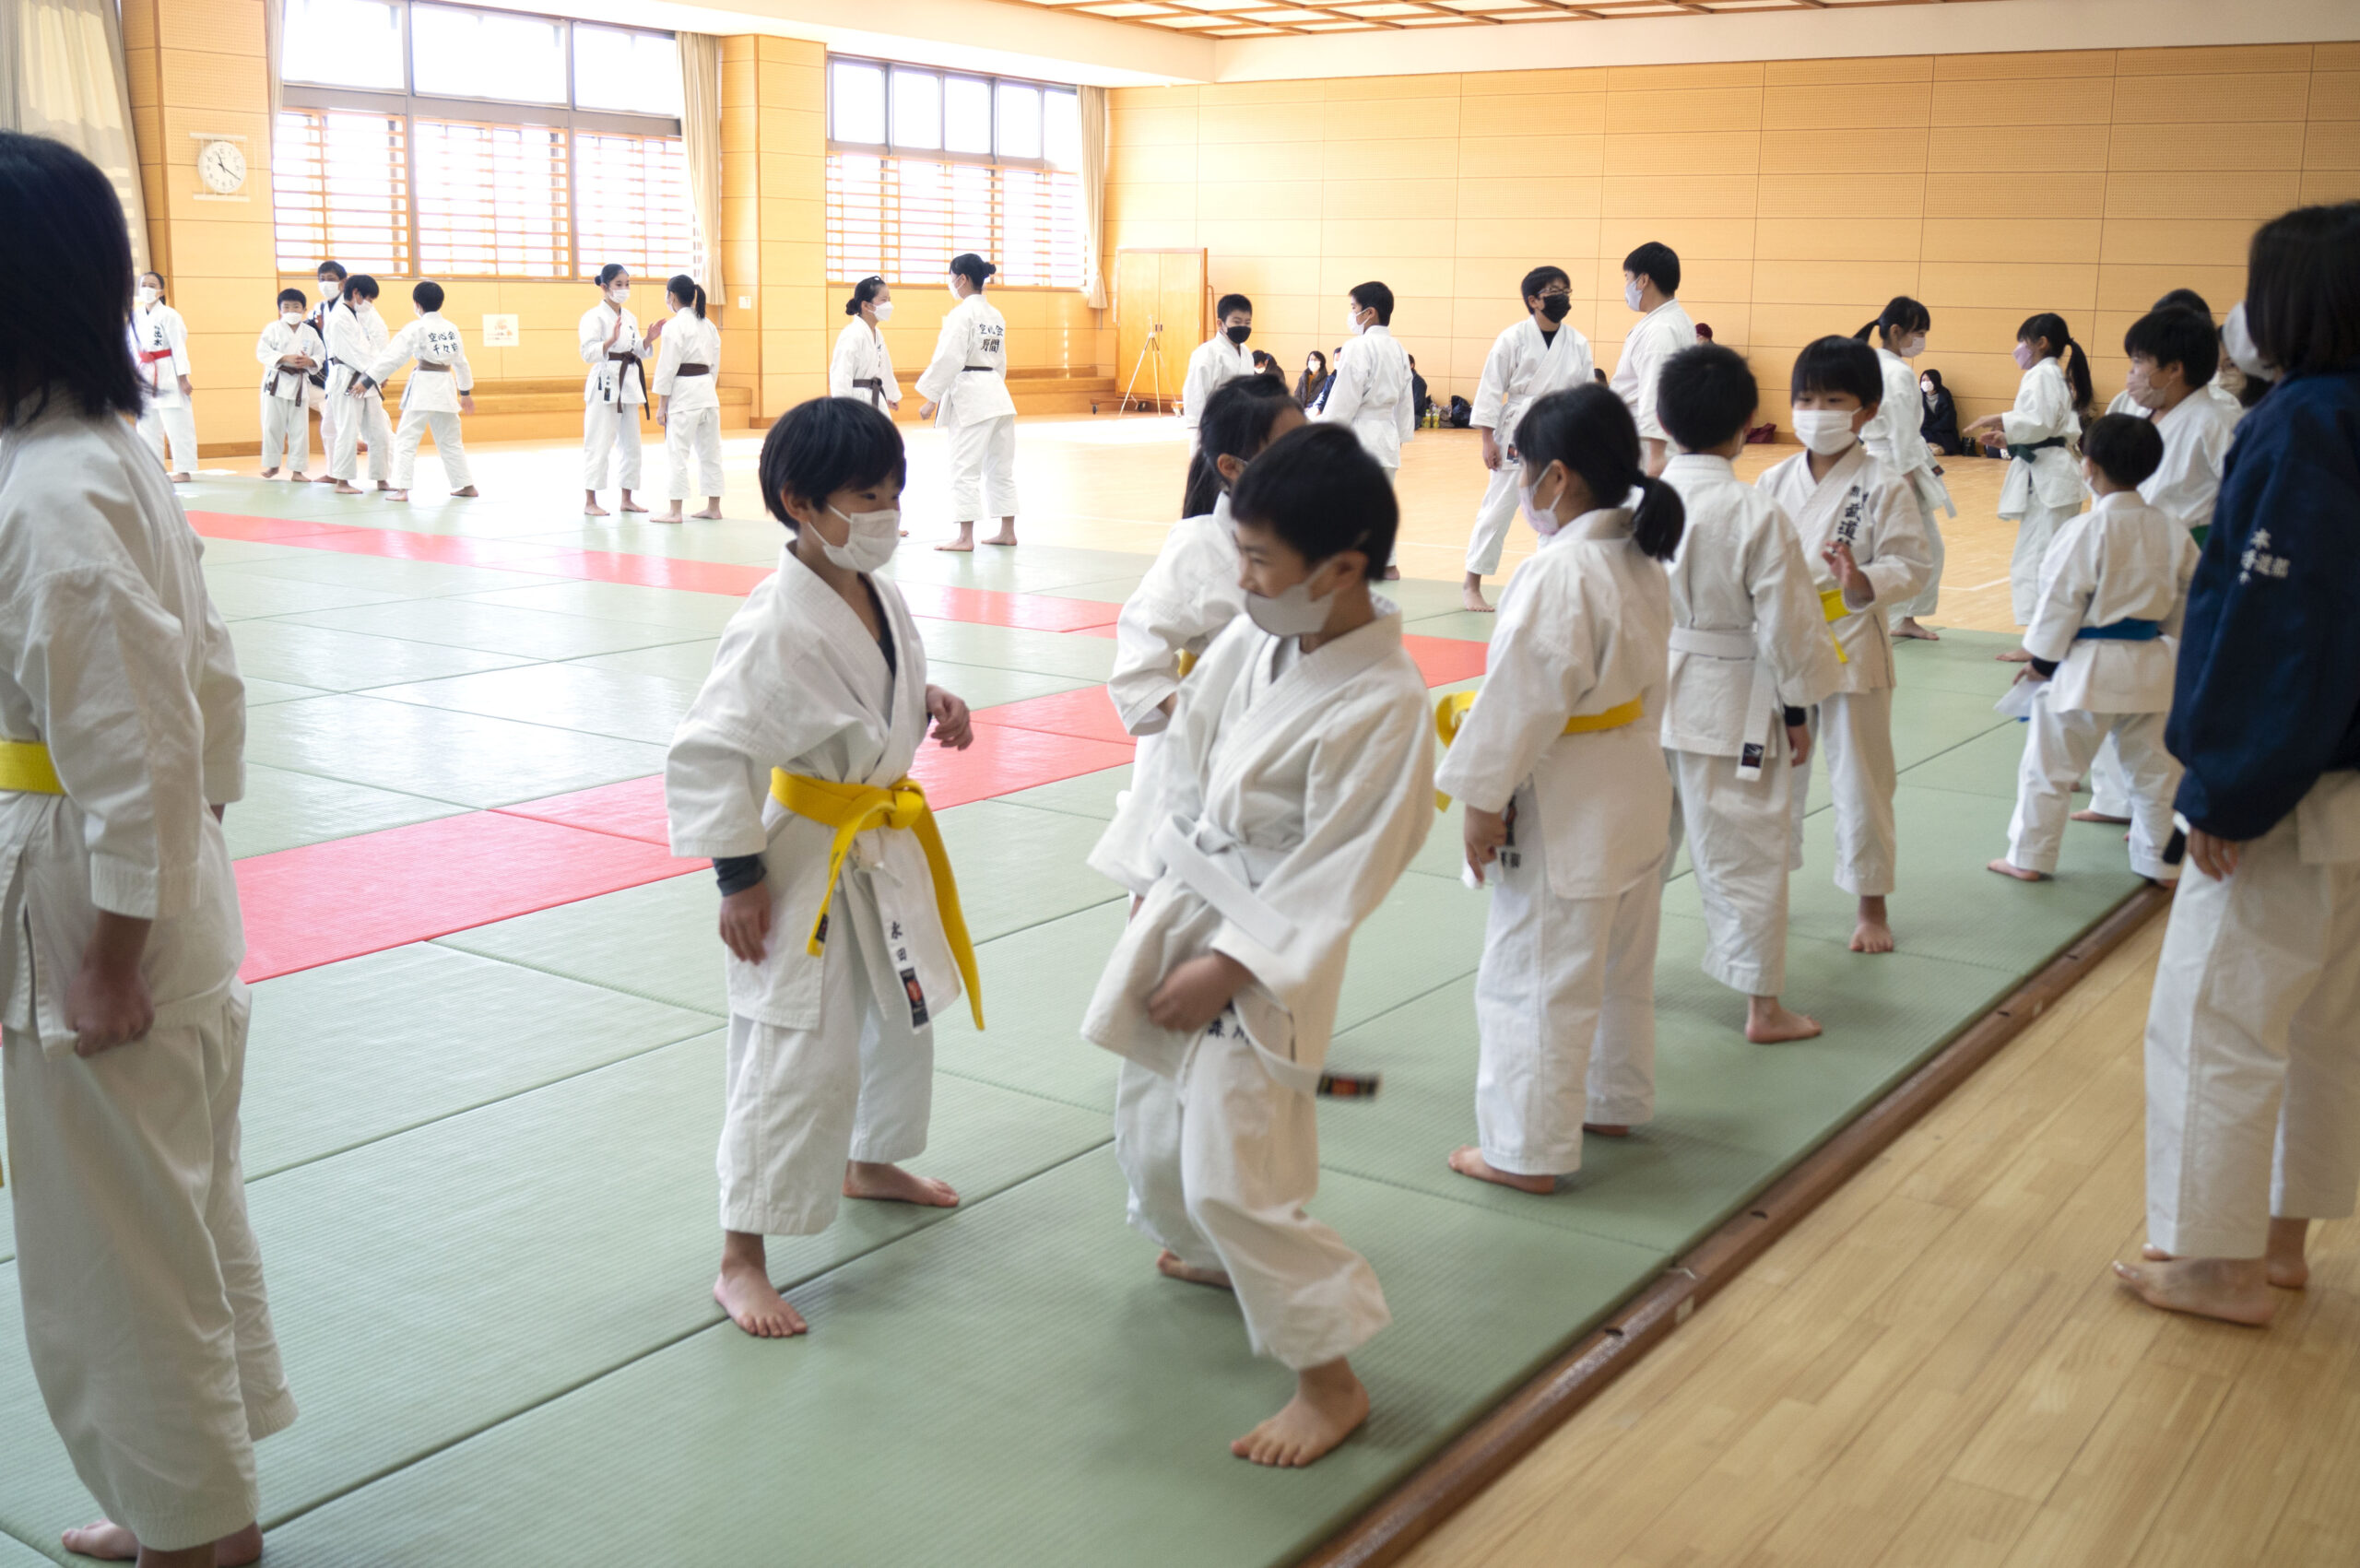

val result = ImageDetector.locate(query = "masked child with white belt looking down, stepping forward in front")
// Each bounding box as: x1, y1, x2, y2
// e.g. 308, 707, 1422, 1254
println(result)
1080, 425, 1434, 1467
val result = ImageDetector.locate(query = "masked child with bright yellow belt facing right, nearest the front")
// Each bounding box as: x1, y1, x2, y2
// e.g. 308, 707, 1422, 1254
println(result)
663, 396, 985, 1339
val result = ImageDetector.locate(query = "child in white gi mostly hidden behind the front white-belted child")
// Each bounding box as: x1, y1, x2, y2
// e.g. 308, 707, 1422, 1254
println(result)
1107, 375, 1303, 784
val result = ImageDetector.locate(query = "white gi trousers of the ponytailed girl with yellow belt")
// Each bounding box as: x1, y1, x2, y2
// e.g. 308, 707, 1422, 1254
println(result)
1475, 784, 1664, 1176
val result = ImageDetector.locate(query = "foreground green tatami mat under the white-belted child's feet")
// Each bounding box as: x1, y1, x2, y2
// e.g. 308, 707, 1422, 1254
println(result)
254, 1150, 1655, 1568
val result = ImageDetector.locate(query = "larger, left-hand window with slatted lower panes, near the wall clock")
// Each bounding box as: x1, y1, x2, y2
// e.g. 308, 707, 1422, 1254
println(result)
271, 0, 689, 278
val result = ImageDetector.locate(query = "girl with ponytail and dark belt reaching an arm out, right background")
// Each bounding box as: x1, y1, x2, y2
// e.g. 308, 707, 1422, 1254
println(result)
1961, 310, 2095, 632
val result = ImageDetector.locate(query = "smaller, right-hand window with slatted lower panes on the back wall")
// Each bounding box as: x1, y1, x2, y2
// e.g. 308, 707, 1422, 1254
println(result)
829, 59, 1080, 289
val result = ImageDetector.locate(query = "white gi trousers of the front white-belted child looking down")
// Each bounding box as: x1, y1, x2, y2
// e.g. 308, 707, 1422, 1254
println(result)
1114, 1008, 1392, 1372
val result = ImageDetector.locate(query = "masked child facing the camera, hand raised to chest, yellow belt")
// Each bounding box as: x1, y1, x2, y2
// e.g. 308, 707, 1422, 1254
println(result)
1753, 337, 1933, 951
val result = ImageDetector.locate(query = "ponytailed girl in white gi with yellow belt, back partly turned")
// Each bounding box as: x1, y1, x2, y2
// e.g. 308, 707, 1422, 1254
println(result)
1434, 387, 1685, 1193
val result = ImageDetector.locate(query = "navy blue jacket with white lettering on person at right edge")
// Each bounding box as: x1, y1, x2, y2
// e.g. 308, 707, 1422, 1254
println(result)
2165, 366, 2360, 841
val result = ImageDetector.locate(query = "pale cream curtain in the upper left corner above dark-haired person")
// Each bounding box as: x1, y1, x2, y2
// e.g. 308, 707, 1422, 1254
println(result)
0, 0, 148, 269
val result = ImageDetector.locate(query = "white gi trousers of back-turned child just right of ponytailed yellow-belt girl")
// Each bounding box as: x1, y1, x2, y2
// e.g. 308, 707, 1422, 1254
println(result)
1670, 725, 1799, 996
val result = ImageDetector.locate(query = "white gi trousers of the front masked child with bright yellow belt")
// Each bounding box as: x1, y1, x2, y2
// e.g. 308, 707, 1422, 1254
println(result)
715, 906, 935, 1235
